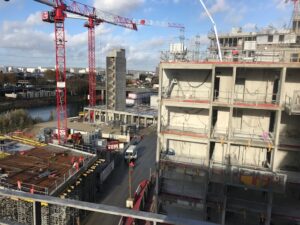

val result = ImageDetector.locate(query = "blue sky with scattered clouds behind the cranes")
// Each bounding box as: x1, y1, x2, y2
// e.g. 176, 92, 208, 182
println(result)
0, 0, 292, 70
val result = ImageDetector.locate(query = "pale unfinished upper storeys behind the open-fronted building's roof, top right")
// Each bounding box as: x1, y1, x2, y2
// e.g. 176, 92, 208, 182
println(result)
208, 1, 300, 62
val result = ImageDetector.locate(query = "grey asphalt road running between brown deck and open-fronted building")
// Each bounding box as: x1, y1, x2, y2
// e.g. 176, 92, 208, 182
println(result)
84, 132, 157, 225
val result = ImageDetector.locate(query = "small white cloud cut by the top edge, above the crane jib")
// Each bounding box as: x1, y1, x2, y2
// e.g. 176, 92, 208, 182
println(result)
94, 0, 145, 15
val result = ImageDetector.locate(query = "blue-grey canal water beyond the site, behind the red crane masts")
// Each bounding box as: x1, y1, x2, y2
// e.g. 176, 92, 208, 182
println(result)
26, 102, 85, 121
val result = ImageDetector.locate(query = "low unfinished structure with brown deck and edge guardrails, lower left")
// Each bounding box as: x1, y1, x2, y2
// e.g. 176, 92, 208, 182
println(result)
0, 136, 107, 225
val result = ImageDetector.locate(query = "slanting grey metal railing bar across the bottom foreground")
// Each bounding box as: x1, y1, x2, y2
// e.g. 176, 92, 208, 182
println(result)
0, 189, 217, 225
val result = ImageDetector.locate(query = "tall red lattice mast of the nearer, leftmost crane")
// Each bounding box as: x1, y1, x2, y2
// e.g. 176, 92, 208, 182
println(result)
54, 5, 67, 143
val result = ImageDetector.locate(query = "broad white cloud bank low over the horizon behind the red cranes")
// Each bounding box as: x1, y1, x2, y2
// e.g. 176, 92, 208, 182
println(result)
0, 9, 167, 69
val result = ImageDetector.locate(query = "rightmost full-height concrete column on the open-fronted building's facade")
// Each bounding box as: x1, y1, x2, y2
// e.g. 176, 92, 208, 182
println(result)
271, 67, 286, 171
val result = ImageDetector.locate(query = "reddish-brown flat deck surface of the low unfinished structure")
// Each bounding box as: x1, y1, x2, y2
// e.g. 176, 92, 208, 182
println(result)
0, 146, 88, 194
